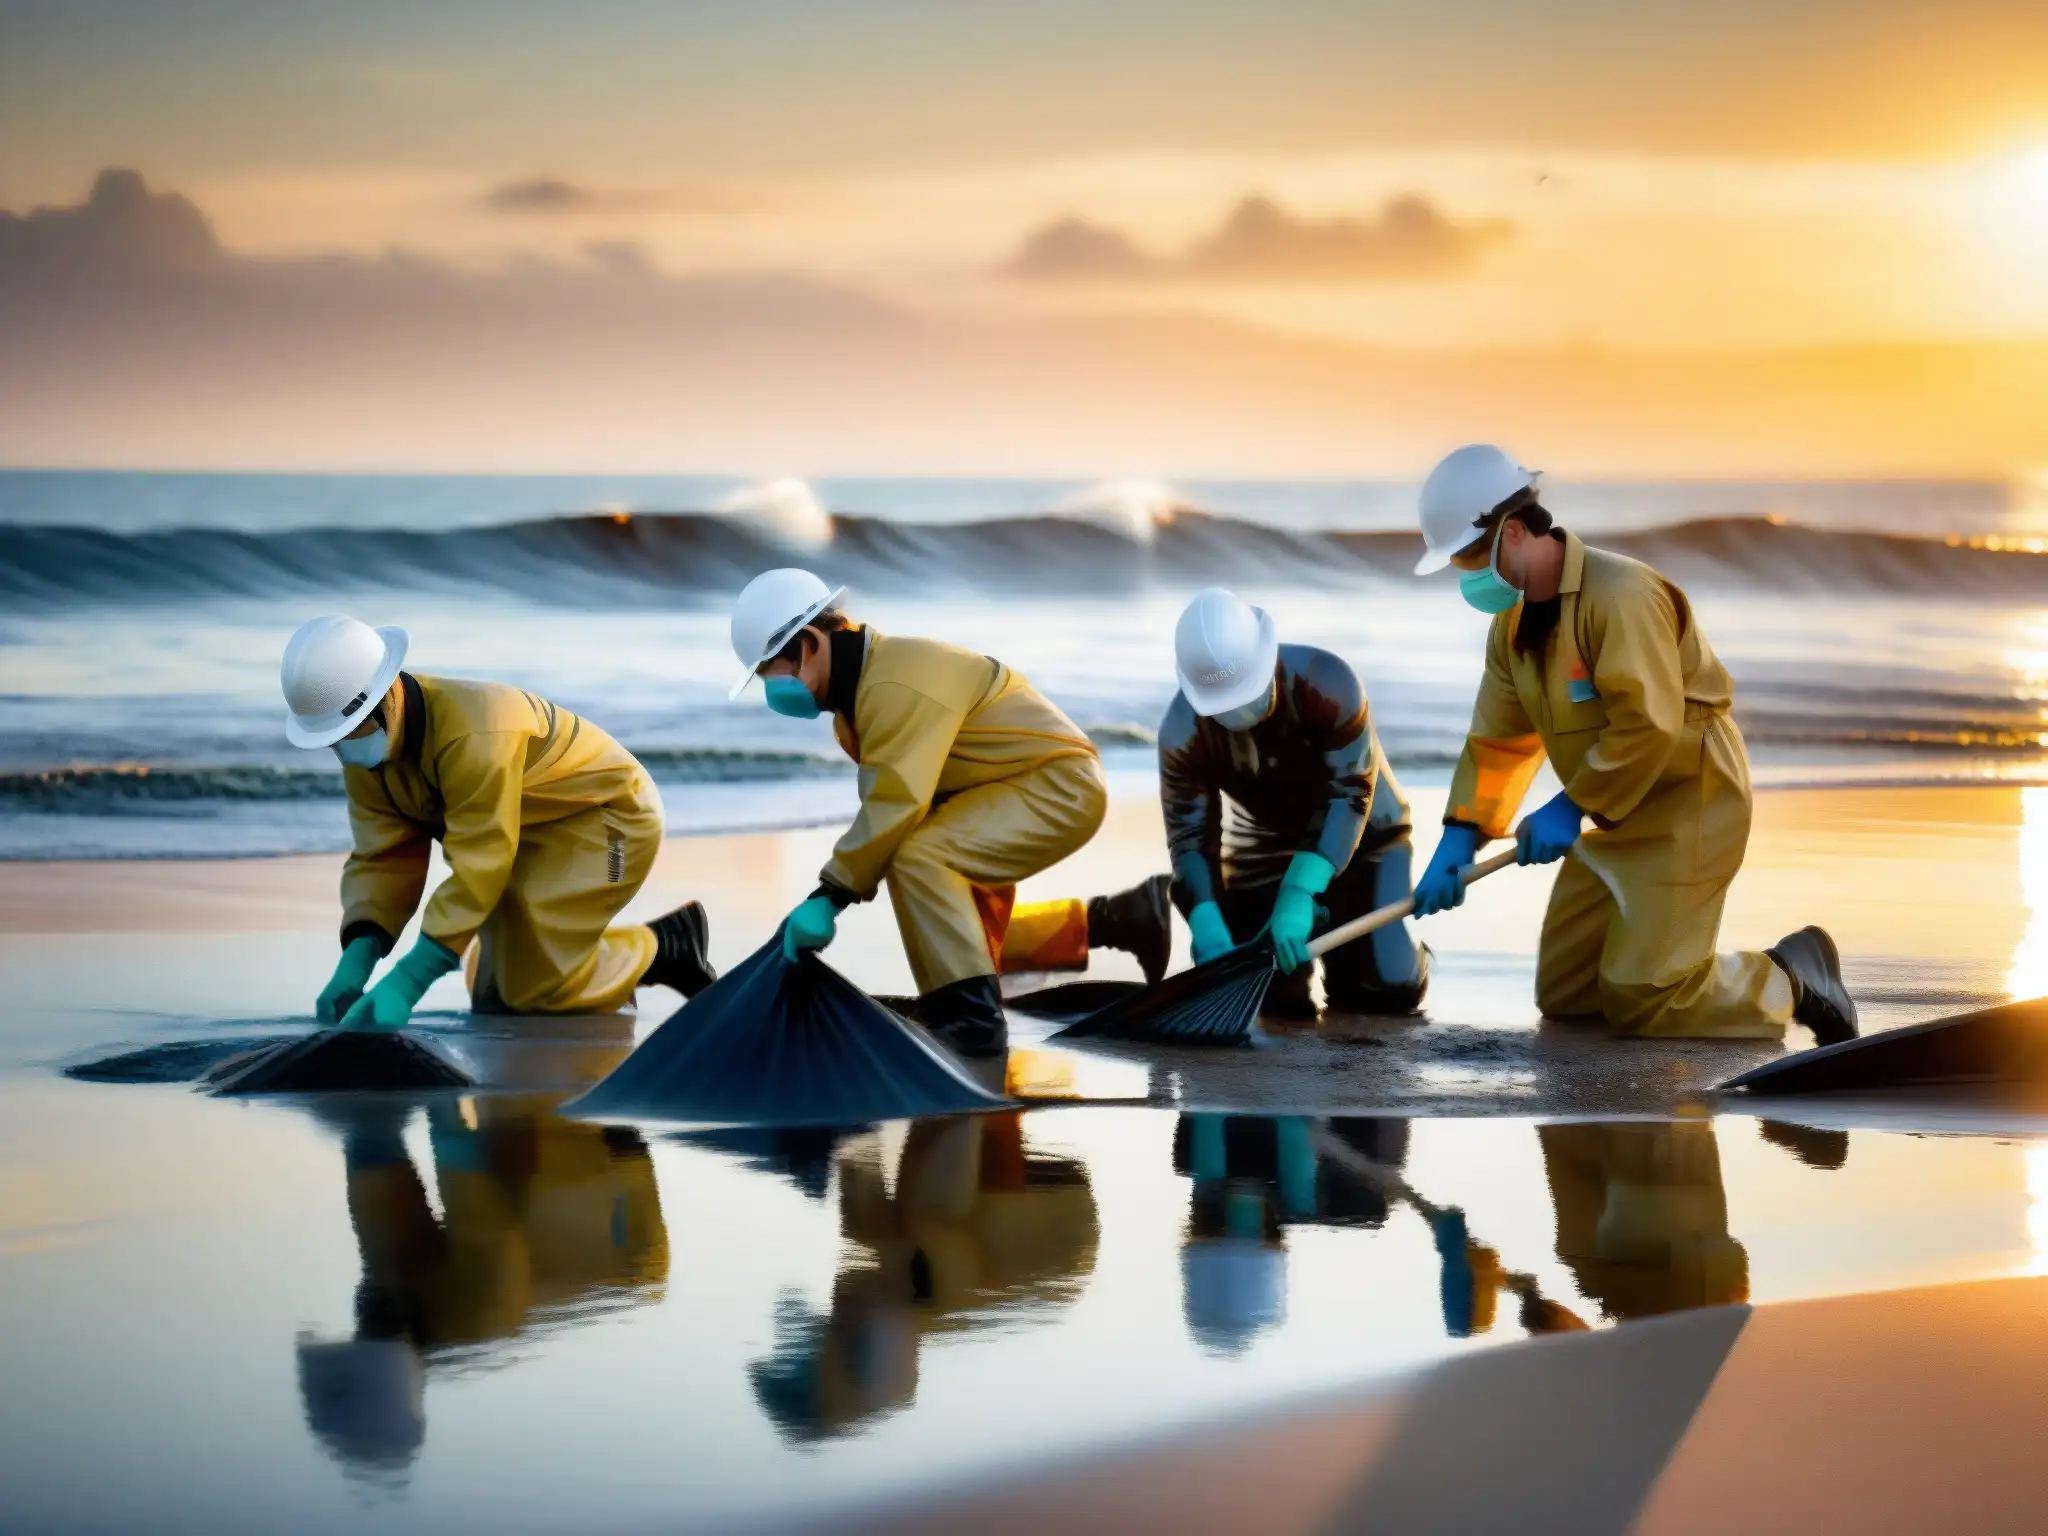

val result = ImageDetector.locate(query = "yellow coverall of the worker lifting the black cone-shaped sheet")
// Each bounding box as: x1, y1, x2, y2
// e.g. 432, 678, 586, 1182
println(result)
823, 629, 1108, 993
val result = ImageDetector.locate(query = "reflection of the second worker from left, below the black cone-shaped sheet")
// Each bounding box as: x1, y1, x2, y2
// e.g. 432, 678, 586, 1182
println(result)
748, 1114, 1100, 1442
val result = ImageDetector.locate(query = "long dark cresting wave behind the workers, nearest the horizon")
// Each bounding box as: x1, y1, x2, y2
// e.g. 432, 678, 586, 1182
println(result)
12, 508, 2048, 610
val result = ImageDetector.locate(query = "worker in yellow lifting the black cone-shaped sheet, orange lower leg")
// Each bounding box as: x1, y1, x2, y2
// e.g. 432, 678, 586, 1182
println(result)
733, 569, 1171, 1057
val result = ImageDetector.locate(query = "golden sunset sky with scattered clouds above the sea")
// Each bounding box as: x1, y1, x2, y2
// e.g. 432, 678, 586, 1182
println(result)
0, 0, 2048, 473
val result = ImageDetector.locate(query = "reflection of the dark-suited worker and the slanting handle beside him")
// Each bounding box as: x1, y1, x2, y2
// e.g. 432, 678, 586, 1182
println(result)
1174, 1114, 1585, 1354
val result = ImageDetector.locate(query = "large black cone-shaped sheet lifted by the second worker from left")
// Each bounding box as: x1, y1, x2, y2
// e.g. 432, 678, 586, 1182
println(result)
563, 932, 1010, 1126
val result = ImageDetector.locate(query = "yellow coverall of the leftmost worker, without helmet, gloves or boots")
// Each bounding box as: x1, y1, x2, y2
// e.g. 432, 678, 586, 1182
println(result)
342, 674, 662, 1014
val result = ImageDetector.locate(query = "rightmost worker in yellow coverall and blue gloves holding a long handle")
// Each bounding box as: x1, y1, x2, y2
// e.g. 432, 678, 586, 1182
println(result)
1415, 444, 1855, 1044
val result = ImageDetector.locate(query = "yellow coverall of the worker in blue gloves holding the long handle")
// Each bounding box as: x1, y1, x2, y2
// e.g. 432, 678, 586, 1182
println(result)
1448, 535, 1792, 1038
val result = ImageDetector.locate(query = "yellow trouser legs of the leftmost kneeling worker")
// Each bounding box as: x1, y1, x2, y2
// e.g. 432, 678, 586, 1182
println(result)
467, 776, 662, 1014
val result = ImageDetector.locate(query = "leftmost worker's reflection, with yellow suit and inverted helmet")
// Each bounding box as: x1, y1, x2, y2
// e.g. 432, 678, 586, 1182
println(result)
299, 1096, 668, 1475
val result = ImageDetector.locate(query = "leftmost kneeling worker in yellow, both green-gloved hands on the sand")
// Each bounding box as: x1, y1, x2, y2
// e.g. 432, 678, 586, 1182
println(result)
283, 616, 717, 1030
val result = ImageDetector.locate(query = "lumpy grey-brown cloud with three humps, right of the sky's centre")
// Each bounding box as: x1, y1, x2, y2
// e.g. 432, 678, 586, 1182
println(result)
1004, 193, 1513, 283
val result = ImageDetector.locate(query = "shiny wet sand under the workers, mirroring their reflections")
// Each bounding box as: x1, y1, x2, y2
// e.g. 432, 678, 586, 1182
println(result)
0, 791, 2048, 1532
